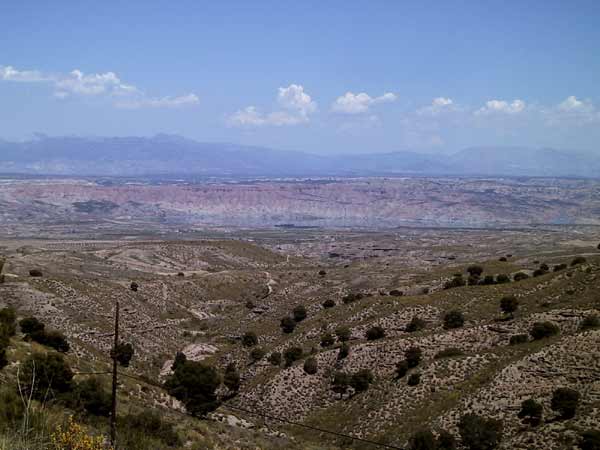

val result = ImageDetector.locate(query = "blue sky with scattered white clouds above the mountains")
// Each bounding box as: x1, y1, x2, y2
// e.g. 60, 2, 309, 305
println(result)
0, 0, 600, 154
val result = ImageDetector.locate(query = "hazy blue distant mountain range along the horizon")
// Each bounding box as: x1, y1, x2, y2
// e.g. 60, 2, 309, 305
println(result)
0, 134, 600, 178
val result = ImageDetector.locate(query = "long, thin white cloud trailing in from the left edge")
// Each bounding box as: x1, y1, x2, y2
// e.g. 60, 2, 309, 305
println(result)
0, 66, 199, 108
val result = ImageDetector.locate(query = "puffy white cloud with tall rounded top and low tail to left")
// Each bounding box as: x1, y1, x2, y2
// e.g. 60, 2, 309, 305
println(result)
227, 84, 317, 127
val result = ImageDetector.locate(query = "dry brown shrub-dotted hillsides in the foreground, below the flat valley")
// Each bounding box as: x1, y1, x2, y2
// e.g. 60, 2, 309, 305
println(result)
0, 231, 600, 449
